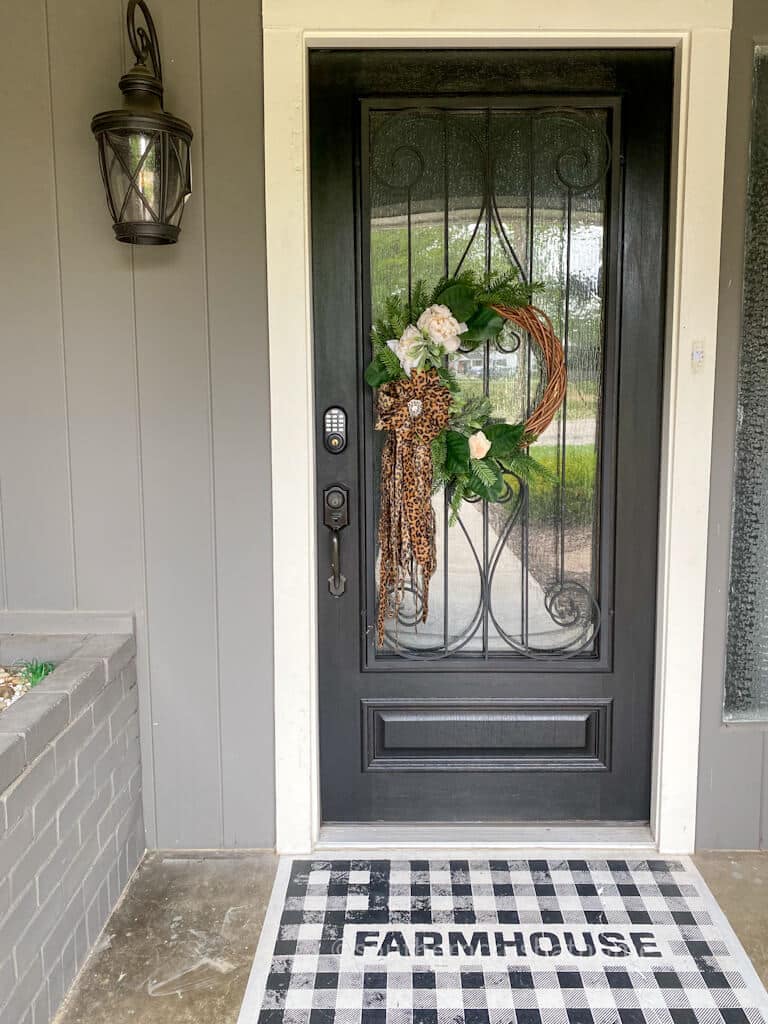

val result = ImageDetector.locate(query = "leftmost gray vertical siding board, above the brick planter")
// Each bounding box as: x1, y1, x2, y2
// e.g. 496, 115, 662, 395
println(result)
0, 3, 76, 608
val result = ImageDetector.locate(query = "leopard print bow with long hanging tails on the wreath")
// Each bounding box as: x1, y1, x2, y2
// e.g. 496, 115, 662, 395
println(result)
376, 370, 451, 647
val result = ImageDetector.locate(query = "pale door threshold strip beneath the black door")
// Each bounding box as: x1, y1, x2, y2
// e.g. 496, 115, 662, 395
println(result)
315, 821, 656, 851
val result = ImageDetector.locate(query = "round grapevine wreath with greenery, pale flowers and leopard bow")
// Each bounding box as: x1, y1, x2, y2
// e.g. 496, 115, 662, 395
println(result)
366, 271, 566, 646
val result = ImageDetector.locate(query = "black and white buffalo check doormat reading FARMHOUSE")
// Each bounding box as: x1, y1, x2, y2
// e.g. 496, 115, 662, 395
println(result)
239, 858, 768, 1024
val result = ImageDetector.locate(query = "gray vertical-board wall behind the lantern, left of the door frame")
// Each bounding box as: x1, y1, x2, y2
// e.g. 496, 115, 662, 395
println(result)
0, 0, 274, 848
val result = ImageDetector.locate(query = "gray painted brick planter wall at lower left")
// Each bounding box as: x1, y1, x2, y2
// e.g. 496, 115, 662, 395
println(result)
0, 635, 144, 1024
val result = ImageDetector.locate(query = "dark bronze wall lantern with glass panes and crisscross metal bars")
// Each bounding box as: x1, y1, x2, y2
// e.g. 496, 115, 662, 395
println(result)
91, 0, 193, 246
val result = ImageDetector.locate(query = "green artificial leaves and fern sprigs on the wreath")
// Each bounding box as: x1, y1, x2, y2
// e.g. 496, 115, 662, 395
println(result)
366, 270, 548, 523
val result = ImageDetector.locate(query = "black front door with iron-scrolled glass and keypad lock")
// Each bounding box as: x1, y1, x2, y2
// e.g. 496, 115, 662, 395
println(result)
313, 50, 673, 822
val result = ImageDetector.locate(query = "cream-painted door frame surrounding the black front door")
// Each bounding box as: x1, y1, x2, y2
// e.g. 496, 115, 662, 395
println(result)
262, 0, 731, 853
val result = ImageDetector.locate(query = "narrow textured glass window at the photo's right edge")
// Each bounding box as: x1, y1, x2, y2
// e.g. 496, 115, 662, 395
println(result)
724, 46, 768, 722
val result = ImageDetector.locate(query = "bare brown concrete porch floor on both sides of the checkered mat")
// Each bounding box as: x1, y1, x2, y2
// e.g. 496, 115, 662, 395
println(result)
56, 853, 768, 1024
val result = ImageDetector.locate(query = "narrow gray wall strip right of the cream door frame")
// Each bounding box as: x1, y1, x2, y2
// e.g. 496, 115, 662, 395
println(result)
696, 0, 768, 850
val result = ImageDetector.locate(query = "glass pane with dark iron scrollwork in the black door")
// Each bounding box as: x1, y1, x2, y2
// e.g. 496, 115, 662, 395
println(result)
369, 105, 611, 660
